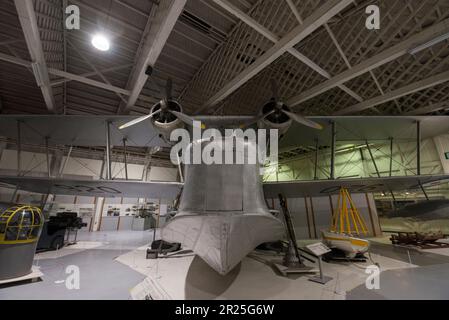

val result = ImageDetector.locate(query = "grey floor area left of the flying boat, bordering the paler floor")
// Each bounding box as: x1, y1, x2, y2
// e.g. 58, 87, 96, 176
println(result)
0, 231, 152, 300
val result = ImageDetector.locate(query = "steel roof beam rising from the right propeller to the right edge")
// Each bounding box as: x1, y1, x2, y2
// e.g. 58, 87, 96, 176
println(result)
287, 19, 449, 106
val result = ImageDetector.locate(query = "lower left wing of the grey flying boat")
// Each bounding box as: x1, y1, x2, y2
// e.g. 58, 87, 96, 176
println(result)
0, 176, 183, 199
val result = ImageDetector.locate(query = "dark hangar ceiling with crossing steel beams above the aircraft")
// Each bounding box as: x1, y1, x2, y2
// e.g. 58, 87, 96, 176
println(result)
0, 0, 449, 115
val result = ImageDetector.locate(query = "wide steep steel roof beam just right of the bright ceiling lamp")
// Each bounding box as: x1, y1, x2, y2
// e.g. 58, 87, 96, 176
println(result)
119, 0, 187, 113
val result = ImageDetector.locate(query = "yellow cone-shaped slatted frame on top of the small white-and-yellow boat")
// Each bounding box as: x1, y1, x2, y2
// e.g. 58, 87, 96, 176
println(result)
331, 188, 368, 235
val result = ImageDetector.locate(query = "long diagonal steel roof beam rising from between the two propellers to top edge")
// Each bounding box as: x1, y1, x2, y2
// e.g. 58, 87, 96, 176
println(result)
201, 0, 352, 110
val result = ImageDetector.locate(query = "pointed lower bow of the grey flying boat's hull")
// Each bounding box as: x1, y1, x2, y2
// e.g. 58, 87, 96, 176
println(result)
162, 214, 284, 275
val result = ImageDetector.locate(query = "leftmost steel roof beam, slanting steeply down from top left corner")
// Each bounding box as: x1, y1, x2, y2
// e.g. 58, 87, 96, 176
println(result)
14, 0, 56, 112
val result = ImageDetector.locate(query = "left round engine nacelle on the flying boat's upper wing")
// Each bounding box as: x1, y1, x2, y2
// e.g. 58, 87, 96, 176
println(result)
151, 100, 184, 141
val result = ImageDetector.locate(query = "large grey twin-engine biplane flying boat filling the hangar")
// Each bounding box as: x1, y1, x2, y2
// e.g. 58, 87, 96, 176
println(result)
0, 82, 449, 275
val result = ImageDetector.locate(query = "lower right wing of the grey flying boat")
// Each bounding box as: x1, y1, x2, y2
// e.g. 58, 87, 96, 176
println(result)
263, 175, 449, 198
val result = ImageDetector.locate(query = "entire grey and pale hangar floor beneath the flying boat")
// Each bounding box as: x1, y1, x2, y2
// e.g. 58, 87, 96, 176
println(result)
0, 231, 449, 300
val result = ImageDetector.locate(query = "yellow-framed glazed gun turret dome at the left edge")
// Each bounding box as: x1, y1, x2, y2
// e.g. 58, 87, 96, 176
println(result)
0, 206, 44, 245
